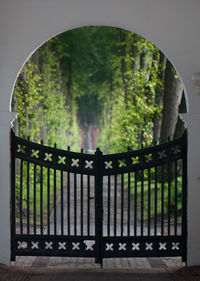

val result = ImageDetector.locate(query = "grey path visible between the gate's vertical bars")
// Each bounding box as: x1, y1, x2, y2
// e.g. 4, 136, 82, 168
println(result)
50, 174, 181, 236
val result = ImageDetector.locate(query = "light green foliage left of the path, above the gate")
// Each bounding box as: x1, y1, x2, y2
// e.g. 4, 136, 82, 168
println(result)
13, 38, 80, 150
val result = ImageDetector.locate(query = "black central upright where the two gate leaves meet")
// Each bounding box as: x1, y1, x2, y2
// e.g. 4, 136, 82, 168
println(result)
95, 148, 103, 266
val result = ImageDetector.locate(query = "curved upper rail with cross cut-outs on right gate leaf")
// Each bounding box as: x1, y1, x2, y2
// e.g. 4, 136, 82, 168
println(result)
103, 135, 187, 175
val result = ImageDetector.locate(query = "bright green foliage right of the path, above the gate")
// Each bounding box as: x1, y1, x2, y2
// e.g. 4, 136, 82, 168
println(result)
99, 30, 163, 153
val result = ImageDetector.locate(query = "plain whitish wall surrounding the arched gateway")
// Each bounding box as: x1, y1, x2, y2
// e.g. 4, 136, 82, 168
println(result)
0, 0, 200, 265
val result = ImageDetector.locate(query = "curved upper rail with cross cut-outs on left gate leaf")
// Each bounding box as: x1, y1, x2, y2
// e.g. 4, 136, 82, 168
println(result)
12, 132, 96, 175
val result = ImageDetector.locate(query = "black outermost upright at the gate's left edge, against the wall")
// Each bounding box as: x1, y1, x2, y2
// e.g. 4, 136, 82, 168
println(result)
11, 130, 16, 261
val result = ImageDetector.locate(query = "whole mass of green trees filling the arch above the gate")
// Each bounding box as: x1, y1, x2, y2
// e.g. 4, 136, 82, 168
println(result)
13, 26, 186, 153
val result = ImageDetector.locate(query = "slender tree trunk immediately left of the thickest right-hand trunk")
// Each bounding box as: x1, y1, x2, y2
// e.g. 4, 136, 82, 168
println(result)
153, 51, 167, 142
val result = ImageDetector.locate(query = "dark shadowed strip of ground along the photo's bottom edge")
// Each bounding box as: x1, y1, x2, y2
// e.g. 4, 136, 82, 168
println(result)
0, 265, 200, 281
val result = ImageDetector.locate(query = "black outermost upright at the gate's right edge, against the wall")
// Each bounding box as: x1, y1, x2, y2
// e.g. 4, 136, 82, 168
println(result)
181, 131, 187, 262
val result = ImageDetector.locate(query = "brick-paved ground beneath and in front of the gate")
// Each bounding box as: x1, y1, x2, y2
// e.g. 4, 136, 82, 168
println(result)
0, 257, 200, 281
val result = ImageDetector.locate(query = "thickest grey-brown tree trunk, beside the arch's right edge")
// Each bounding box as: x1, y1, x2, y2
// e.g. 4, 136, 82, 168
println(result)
160, 60, 182, 142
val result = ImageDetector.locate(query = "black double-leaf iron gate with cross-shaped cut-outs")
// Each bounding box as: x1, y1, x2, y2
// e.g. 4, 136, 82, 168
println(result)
11, 132, 187, 264
